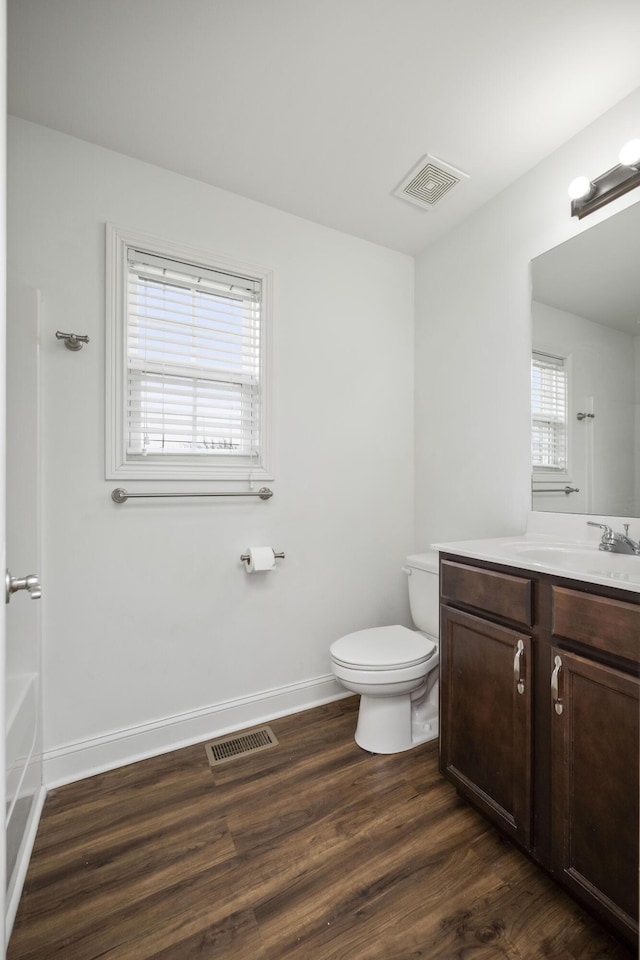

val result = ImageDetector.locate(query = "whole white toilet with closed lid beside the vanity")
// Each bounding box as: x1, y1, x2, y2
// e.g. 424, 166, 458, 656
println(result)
330, 552, 440, 753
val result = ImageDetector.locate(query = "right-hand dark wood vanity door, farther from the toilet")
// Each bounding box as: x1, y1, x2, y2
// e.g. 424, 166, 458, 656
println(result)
551, 648, 639, 941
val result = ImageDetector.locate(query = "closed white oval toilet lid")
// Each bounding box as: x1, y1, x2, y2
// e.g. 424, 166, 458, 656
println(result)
330, 624, 437, 670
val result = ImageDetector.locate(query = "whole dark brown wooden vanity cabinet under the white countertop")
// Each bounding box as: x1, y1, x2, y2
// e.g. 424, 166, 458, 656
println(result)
440, 555, 640, 943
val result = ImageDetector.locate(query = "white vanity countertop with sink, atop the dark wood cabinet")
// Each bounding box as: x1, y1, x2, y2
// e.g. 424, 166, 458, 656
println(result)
431, 514, 640, 593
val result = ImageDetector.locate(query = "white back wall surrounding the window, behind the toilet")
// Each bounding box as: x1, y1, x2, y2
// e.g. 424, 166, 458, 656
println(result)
8, 119, 414, 782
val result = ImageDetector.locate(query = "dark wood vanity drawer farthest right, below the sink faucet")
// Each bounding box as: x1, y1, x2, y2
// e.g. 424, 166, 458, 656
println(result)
552, 586, 640, 662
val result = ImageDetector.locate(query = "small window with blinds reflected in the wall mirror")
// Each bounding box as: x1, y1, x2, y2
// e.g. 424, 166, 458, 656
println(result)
531, 351, 568, 480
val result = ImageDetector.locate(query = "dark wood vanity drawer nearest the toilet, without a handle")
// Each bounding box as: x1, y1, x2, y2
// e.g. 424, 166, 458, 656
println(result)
440, 560, 533, 627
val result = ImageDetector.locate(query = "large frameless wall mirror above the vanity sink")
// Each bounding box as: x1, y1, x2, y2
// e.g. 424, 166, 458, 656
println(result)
532, 203, 640, 518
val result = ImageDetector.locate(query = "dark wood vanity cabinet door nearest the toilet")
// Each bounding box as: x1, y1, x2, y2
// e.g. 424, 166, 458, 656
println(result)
440, 606, 532, 848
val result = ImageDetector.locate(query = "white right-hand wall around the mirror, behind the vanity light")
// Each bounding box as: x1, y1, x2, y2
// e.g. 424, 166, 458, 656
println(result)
416, 90, 640, 549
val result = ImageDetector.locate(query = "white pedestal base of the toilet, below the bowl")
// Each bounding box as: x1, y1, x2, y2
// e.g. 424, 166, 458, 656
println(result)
355, 693, 438, 753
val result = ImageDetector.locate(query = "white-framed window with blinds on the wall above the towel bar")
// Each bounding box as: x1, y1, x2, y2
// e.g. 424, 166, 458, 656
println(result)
107, 227, 270, 479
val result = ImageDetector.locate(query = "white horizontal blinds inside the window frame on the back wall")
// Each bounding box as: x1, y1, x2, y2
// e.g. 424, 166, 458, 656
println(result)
125, 248, 262, 465
